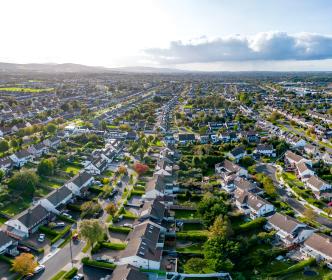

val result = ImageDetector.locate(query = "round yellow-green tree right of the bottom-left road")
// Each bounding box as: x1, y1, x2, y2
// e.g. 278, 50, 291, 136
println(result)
79, 219, 104, 246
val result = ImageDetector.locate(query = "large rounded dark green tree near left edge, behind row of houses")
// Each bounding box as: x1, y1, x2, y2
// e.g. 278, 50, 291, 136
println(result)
8, 170, 39, 197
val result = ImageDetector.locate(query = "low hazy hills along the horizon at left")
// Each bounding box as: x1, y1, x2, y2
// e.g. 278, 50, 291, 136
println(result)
0, 62, 185, 73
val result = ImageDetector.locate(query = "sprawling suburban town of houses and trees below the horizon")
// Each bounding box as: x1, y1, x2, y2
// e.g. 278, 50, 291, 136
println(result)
0, 70, 332, 280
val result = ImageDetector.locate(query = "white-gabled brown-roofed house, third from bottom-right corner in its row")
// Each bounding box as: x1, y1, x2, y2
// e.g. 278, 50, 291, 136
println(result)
234, 189, 274, 219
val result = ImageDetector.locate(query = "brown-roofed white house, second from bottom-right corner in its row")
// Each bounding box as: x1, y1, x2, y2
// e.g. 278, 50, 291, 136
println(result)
265, 212, 315, 245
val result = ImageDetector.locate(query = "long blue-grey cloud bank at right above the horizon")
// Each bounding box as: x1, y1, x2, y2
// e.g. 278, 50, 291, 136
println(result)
144, 31, 332, 64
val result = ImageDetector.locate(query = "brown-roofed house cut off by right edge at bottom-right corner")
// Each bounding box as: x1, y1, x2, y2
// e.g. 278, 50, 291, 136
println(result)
300, 233, 332, 269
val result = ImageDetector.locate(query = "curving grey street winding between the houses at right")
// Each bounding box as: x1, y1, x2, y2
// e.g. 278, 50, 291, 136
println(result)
256, 164, 332, 228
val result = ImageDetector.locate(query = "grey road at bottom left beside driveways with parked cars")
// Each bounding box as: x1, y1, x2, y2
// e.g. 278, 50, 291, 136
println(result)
34, 238, 85, 280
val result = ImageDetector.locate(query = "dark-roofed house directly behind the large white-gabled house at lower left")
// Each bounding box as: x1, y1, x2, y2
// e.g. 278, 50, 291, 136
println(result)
39, 186, 73, 215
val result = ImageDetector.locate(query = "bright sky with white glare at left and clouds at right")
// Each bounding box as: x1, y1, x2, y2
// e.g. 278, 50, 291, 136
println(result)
0, 0, 332, 71
